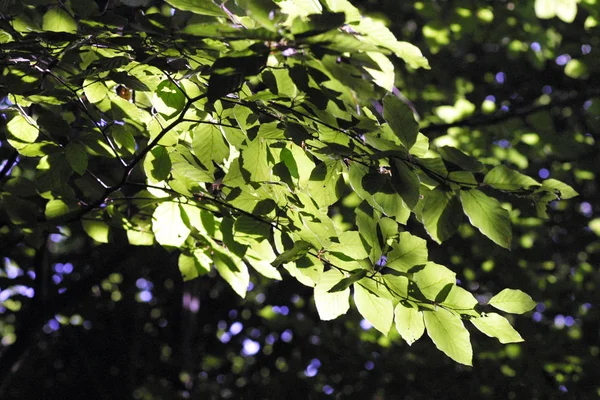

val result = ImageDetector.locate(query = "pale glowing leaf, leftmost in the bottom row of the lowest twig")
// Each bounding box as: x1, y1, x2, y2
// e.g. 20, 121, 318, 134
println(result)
315, 269, 350, 321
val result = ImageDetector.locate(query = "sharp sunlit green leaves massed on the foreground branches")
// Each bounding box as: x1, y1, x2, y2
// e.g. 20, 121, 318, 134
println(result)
0, 0, 587, 396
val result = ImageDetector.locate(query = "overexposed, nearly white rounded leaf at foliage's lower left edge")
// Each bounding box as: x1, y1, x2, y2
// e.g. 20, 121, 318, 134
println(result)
152, 201, 191, 247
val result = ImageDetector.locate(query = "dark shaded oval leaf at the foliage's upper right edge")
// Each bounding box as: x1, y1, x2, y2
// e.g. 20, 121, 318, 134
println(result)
383, 94, 419, 150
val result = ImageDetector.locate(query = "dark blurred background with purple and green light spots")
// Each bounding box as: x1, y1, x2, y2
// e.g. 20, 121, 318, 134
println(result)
0, 0, 600, 399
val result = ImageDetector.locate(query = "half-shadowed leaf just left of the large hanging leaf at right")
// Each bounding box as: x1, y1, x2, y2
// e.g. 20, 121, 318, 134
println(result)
422, 185, 463, 243
